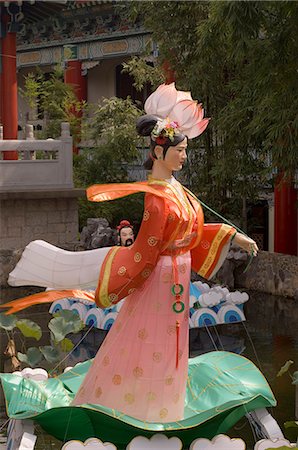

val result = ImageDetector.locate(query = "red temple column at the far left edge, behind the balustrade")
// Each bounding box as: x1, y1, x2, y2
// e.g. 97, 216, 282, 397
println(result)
1, 24, 18, 159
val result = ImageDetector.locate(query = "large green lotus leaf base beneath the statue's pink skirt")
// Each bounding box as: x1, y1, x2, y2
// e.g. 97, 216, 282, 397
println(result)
1, 352, 276, 449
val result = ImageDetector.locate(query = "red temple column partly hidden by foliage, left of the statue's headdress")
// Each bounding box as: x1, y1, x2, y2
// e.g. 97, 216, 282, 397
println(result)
64, 60, 87, 153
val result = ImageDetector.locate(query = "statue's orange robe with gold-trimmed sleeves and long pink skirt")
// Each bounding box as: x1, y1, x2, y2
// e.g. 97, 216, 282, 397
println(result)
74, 179, 235, 422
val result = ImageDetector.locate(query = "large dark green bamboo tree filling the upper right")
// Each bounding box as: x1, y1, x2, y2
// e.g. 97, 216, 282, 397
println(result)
124, 1, 298, 230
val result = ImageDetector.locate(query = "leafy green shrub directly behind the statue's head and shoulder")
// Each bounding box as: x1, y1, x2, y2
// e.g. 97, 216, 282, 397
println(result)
74, 97, 143, 226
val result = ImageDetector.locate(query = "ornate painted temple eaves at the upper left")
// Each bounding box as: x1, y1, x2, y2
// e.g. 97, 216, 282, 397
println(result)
0, 0, 150, 67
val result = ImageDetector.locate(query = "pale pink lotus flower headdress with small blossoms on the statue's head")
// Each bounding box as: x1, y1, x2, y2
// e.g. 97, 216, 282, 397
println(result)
145, 83, 209, 141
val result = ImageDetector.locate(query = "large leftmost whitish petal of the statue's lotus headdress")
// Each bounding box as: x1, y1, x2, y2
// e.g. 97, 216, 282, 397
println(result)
144, 83, 177, 118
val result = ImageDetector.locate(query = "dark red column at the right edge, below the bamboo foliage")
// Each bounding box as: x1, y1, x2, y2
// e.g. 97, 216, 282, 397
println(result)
274, 176, 297, 255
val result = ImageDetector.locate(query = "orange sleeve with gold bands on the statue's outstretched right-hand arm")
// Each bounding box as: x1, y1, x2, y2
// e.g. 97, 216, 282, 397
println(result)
191, 223, 236, 280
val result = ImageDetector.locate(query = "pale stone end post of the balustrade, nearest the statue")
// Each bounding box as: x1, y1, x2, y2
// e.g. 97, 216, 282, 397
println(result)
59, 122, 73, 188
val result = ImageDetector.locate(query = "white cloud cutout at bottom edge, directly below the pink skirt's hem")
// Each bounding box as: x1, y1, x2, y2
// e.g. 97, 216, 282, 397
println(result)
127, 434, 182, 450
